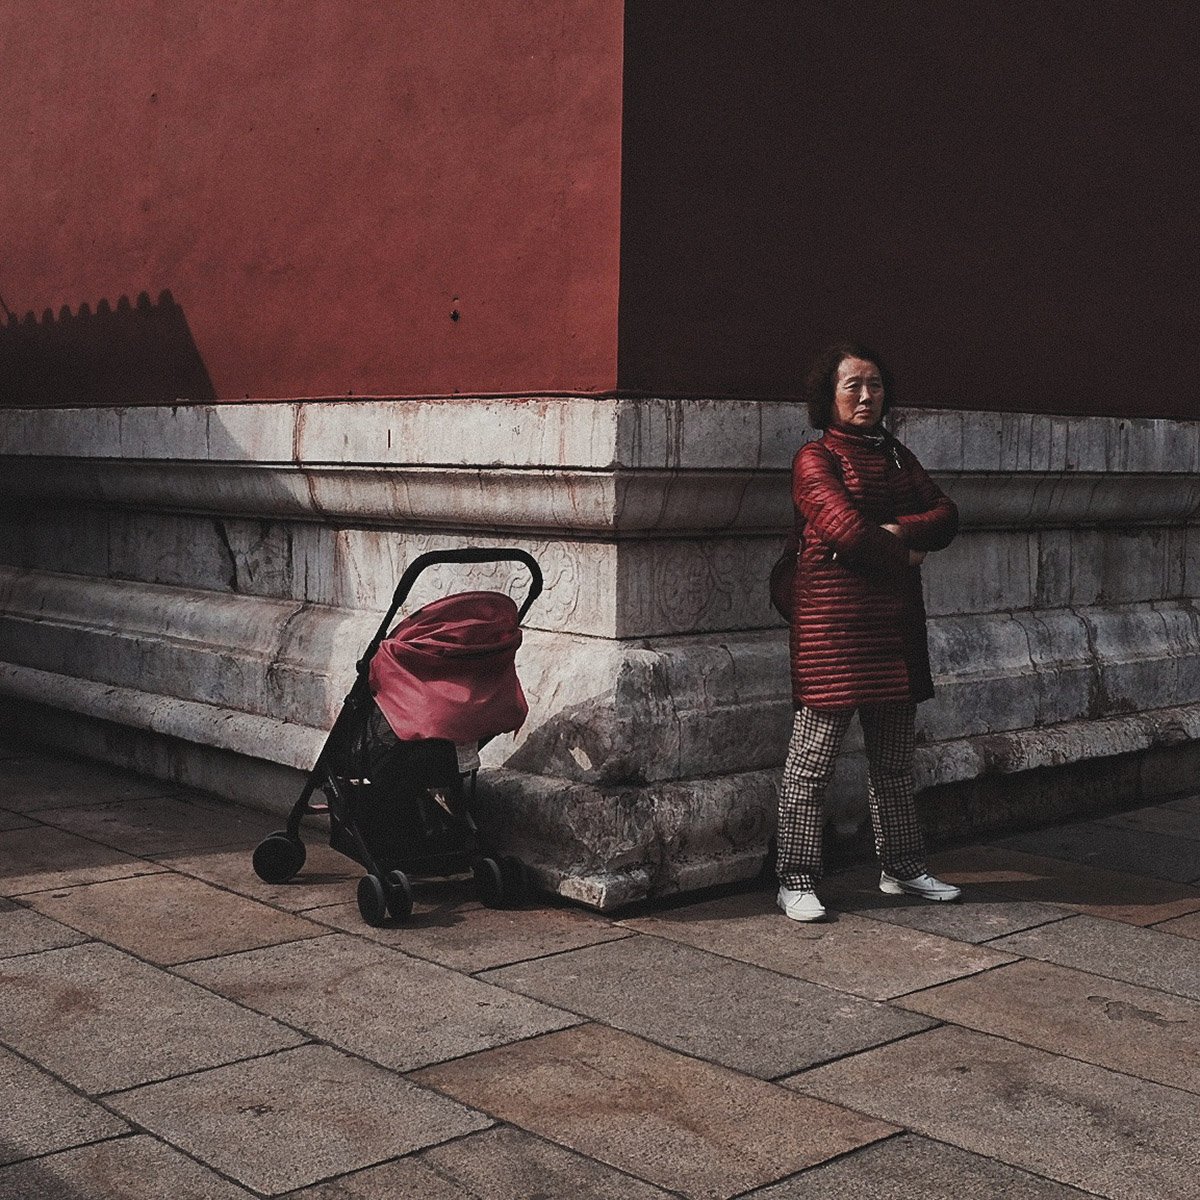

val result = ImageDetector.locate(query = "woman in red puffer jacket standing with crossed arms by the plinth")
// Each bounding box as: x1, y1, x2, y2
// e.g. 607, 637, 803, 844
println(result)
776, 342, 960, 920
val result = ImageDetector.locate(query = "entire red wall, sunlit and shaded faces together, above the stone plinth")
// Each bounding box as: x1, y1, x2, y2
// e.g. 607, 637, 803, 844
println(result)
9, 0, 1200, 416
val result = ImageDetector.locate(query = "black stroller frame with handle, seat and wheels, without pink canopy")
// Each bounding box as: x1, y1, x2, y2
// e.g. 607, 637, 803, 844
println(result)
253, 548, 542, 925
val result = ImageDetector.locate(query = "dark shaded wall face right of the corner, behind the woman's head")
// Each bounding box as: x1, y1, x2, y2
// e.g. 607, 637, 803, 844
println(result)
619, 0, 1200, 416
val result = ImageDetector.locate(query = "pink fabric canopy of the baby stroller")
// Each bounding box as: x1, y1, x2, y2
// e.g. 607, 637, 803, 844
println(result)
370, 592, 529, 743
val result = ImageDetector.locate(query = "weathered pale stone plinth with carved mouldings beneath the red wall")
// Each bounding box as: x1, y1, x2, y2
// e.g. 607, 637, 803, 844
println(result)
0, 397, 1200, 907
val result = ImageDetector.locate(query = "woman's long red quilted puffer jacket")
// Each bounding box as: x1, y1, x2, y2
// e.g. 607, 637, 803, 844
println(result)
791, 427, 959, 709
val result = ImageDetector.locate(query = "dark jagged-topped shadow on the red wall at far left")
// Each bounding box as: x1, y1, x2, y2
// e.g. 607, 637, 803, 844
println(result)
0, 292, 217, 407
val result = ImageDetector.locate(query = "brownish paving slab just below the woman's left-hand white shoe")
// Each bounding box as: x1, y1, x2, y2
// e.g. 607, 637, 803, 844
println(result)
622, 890, 1013, 1000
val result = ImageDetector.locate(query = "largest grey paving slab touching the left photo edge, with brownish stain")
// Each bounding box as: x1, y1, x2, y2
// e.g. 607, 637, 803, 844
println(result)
0, 942, 304, 1093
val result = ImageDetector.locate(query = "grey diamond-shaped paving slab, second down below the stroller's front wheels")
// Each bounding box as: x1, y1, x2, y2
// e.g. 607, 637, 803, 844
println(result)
178, 934, 580, 1070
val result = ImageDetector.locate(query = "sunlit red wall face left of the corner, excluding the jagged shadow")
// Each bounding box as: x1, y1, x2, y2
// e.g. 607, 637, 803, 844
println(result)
7, 0, 622, 400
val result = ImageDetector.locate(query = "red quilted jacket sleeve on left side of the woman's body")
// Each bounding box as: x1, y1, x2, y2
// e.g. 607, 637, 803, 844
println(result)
792, 442, 908, 574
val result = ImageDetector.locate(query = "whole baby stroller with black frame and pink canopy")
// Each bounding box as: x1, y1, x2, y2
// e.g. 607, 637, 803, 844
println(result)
253, 550, 542, 925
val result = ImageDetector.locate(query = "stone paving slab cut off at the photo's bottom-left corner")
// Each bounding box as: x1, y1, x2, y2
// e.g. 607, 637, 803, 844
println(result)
0, 1136, 252, 1200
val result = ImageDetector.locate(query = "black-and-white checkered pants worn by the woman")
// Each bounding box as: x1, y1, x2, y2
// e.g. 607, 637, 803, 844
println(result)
775, 702, 925, 890
